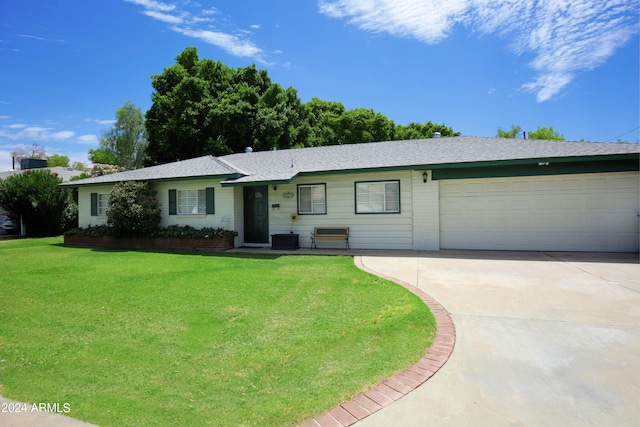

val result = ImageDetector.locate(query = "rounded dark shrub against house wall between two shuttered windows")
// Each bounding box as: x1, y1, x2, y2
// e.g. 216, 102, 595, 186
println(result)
107, 181, 160, 237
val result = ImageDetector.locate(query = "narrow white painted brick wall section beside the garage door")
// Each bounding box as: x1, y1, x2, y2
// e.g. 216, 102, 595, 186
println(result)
412, 171, 440, 251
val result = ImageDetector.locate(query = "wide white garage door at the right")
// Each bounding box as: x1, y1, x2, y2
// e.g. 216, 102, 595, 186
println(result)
440, 172, 640, 252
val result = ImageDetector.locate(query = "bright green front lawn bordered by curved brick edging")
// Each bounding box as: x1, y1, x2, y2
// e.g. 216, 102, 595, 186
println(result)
0, 238, 435, 426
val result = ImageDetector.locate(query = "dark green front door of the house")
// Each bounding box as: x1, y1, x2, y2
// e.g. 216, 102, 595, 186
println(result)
244, 185, 269, 243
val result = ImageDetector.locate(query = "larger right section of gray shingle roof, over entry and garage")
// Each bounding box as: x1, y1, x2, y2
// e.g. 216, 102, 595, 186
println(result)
222, 137, 640, 183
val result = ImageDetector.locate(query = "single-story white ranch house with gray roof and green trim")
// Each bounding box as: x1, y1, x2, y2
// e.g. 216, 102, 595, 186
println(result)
61, 137, 640, 252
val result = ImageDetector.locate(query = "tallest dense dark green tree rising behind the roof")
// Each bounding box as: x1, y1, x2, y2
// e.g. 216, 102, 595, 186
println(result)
146, 47, 307, 164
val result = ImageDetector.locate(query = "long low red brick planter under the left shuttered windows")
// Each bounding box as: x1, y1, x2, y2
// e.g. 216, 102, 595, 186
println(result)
64, 236, 234, 251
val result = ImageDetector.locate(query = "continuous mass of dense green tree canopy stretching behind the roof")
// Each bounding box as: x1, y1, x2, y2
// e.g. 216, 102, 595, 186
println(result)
146, 47, 460, 165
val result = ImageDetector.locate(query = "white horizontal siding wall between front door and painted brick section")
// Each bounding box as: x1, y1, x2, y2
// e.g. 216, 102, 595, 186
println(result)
269, 171, 422, 249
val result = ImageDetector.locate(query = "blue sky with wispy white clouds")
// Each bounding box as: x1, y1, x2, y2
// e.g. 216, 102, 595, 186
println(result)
0, 0, 640, 171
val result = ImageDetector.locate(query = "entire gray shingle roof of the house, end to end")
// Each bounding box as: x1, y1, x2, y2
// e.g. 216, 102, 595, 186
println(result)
61, 136, 640, 184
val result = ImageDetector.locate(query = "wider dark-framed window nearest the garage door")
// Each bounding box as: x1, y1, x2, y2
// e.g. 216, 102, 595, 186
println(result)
356, 181, 400, 214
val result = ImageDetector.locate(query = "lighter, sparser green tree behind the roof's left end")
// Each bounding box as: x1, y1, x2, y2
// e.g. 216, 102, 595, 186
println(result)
89, 101, 147, 169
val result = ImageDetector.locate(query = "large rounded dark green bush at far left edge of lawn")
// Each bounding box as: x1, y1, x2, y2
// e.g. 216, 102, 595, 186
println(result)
0, 169, 77, 236
